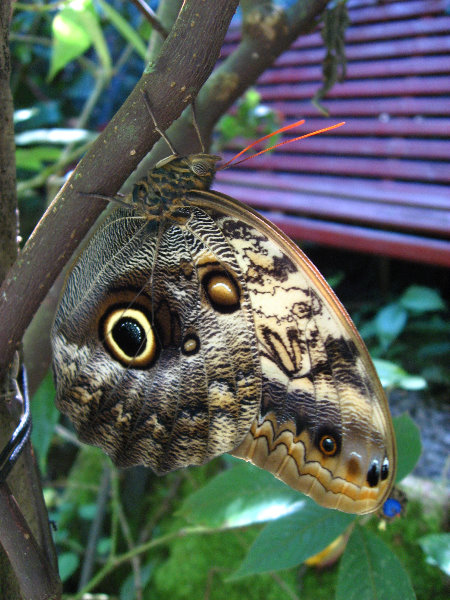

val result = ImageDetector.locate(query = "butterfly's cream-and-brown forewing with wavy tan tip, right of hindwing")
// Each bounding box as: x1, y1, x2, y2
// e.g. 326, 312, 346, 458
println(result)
192, 193, 396, 513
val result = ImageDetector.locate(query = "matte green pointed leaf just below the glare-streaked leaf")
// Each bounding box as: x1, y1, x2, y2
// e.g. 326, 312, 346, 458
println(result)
232, 498, 356, 579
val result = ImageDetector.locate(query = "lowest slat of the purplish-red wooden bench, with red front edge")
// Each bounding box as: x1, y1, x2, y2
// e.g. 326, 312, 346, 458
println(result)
262, 212, 450, 267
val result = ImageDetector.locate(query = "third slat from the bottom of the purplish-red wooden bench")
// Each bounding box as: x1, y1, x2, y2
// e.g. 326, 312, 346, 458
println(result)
216, 167, 450, 211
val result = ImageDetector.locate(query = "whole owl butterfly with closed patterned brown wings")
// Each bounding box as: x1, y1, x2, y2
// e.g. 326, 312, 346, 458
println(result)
52, 102, 396, 513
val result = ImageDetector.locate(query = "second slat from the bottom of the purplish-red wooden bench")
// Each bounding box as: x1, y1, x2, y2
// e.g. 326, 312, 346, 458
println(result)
215, 182, 450, 235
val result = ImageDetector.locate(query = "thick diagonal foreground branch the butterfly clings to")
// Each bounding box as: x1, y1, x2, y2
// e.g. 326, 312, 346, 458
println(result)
0, 0, 237, 372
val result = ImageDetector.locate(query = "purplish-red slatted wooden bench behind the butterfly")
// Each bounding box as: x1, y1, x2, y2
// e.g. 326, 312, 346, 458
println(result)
215, 0, 450, 266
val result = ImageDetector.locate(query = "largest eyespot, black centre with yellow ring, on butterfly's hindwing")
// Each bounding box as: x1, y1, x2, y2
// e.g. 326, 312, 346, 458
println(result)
100, 305, 157, 369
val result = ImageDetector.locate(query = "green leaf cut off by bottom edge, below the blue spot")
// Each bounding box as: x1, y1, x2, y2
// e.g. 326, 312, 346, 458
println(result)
336, 526, 416, 600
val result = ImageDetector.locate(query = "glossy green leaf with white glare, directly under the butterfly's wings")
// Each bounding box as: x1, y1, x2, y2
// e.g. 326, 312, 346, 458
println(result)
179, 463, 305, 528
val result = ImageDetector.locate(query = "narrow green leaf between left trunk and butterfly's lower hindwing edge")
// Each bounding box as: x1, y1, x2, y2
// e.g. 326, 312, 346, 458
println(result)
31, 372, 59, 473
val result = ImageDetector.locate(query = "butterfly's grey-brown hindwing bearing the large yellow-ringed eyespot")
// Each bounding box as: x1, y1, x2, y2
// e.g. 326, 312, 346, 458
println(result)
52, 209, 261, 473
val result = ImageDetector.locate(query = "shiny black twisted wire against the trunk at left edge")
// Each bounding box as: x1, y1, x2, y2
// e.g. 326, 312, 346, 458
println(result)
0, 366, 31, 483
